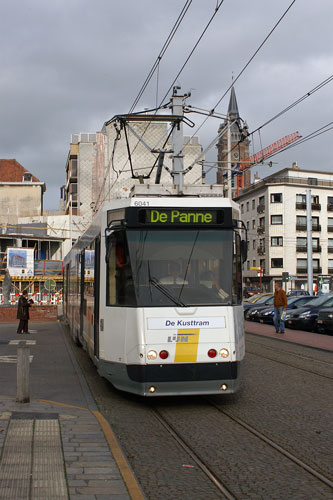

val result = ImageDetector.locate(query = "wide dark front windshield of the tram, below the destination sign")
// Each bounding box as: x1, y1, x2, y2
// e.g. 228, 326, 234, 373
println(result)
107, 230, 241, 307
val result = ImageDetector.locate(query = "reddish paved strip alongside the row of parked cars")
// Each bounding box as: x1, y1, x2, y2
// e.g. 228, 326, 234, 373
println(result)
244, 321, 333, 351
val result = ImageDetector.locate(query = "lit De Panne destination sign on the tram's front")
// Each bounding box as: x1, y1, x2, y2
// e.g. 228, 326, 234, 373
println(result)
132, 207, 231, 227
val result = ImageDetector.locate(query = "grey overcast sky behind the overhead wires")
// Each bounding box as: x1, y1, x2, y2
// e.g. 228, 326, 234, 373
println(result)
0, 0, 333, 209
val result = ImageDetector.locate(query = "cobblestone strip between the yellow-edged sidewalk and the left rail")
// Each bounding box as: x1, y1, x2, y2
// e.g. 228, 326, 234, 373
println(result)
69, 332, 225, 500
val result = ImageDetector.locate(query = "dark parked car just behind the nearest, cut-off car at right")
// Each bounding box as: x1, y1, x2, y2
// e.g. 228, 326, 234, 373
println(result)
285, 293, 333, 331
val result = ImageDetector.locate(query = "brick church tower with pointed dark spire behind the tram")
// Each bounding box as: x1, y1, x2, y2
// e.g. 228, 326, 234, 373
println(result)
216, 87, 251, 198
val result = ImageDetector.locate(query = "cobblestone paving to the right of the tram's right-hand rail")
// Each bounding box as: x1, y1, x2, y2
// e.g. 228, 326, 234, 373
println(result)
215, 338, 333, 478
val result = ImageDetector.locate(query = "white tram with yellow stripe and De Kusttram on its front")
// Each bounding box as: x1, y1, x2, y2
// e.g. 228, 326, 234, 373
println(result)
63, 189, 246, 396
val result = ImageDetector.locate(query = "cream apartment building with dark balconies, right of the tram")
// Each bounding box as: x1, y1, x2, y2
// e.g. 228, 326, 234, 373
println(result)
236, 164, 333, 291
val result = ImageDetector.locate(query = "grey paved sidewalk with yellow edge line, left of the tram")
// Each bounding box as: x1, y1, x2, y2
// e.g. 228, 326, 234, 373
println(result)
0, 322, 144, 500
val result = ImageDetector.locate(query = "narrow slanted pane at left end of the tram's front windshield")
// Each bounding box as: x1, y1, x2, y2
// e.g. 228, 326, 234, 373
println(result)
106, 231, 136, 307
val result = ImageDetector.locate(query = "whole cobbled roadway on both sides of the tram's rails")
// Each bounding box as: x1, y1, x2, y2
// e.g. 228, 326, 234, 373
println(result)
70, 328, 333, 500
